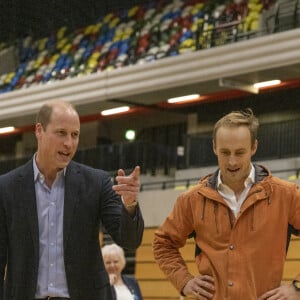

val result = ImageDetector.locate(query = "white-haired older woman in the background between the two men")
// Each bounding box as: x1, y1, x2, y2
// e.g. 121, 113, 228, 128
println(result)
102, 244, 143, 300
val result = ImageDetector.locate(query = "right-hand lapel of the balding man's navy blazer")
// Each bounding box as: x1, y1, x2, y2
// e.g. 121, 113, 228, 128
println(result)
63, 162, 81, 249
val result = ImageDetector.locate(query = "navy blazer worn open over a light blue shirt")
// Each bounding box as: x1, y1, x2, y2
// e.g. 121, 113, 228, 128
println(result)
0, 160, 144, 300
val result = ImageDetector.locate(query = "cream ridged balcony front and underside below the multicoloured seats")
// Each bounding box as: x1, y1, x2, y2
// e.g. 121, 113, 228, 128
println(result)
0, 28, 300, 127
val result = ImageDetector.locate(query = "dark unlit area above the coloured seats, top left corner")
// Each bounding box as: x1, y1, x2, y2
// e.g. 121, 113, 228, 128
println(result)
0, 0, 147, 41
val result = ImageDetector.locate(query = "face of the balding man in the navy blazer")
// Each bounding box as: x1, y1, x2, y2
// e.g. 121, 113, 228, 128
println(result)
36, 107, 80, 171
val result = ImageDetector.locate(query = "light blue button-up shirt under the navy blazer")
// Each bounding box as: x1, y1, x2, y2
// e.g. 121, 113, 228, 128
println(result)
33, 157, 69, 298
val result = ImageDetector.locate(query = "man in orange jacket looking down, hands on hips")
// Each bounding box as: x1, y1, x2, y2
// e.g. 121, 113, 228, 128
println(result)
153, 109, 300, 300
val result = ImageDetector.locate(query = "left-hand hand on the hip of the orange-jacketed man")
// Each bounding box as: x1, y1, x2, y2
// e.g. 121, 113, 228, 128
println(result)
182, 275, 215, 300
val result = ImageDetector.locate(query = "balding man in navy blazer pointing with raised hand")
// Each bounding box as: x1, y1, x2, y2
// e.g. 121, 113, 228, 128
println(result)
0, 100, 144, 300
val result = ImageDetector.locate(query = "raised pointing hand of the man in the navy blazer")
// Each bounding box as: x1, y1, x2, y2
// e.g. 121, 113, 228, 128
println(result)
113, 166, 140, 210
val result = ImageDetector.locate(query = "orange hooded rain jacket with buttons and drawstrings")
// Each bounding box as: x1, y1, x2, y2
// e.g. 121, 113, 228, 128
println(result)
153, 165, 300, 300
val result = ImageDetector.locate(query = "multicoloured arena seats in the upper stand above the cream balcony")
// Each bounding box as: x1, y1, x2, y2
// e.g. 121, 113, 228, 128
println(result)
0, 0, 292, 93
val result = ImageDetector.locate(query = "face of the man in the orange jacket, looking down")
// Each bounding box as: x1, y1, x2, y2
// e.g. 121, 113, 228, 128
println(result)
214, 126, 257, 190
